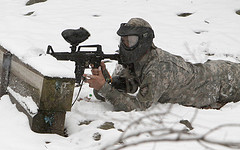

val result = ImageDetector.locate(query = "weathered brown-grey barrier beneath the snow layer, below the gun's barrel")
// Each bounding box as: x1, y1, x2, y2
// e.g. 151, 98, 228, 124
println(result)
0, 46, 75, 135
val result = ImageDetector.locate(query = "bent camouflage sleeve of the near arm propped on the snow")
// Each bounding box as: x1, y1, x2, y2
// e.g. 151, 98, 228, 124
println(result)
99, 72, 159, 111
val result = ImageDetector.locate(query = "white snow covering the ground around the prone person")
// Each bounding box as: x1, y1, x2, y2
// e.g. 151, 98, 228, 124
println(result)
0, 0, 240, 150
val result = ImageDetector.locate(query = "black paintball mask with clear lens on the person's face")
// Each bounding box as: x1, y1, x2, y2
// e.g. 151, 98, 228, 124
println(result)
117, 23, 154, 65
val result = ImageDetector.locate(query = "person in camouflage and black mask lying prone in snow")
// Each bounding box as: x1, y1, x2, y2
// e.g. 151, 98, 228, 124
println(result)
86, 18, 240, 111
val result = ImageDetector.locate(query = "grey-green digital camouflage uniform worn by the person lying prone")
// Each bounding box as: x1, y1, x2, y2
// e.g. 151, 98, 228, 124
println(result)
98, 48, 240, 111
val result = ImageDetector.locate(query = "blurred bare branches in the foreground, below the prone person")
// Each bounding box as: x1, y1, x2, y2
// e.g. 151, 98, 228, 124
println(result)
103, 110, 240, 150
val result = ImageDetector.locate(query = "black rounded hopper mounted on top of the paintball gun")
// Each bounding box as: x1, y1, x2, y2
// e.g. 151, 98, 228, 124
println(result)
62, 27, 90, 47
